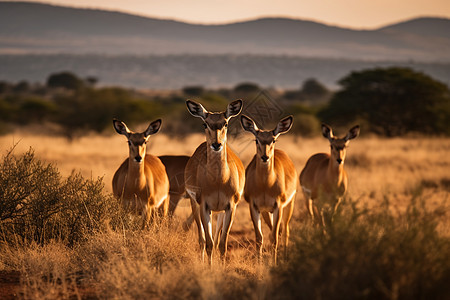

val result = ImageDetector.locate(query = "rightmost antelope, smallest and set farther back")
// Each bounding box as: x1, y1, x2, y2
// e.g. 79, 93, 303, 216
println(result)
300, 124, 359, 228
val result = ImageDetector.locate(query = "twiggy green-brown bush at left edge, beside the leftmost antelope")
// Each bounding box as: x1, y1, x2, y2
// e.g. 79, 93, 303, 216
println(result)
0, 146, 122, 245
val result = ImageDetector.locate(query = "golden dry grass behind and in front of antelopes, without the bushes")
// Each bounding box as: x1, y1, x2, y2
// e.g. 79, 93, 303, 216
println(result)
0, 132, 450, 299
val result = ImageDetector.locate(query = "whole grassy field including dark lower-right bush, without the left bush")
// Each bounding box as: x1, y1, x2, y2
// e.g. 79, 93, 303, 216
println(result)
0, 132, 450, 299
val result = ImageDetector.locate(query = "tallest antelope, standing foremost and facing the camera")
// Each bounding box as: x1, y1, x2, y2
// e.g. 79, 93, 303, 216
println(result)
185, 100, 245, 265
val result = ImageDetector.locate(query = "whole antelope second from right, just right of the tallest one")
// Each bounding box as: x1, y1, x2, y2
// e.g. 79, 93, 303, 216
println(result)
241, 115, 298, 264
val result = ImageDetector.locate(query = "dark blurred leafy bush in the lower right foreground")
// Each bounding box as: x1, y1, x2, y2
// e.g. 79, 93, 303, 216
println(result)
272, 199, 450, 299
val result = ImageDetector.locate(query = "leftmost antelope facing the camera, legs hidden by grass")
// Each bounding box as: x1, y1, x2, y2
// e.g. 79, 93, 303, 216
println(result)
112, 119, 169, 228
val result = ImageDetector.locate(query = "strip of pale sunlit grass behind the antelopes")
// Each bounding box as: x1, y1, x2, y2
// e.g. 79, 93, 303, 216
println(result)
0, 128, 450, 211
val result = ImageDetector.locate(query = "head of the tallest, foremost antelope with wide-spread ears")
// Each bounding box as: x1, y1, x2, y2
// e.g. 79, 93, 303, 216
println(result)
186, 100, 242, 152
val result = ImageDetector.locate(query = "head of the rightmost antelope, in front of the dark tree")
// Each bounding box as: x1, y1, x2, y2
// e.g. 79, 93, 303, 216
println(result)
322, 124, 359, 165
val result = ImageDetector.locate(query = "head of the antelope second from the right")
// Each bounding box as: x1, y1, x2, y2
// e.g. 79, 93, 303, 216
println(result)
241, 115, 294, 163
